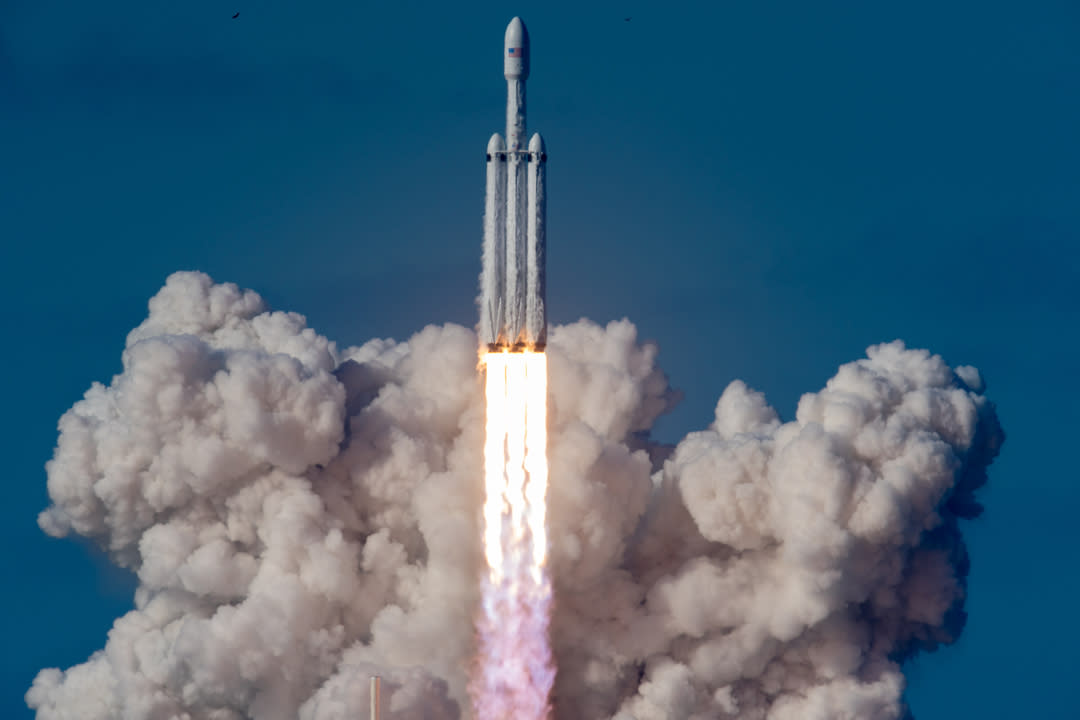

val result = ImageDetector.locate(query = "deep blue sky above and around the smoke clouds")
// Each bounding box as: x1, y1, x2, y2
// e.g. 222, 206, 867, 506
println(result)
0, 0, 1080, 720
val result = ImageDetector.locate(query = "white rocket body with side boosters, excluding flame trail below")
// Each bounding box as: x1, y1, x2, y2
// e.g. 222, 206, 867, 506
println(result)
480, 17, 548, 352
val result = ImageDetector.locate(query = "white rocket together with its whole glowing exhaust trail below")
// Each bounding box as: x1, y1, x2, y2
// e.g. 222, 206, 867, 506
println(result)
470, 17, 555, 720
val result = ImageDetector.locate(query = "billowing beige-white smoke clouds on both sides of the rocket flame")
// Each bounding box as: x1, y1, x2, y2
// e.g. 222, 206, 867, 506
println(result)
27, 273, 1003, 720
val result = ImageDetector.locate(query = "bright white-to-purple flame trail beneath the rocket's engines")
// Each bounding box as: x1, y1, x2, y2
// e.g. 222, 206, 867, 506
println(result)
470, 352, 555, 720
